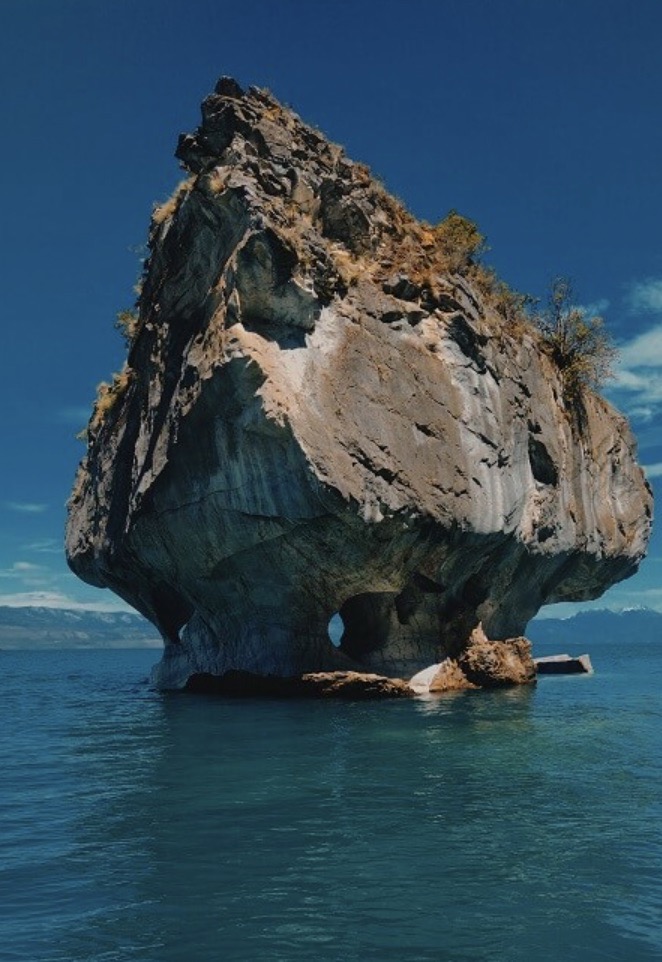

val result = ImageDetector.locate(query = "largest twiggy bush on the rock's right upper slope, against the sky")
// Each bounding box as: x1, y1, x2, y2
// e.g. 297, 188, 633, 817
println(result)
534, 277, 618, 400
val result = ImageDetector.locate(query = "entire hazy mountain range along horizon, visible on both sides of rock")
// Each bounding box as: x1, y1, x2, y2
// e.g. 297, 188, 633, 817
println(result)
0, 606, 662, 652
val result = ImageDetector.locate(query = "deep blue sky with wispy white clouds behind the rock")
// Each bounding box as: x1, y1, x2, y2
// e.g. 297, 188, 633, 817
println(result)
0, 0, 662, 614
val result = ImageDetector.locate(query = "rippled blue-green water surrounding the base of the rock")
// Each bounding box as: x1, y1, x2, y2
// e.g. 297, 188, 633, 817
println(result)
0, 642, 662, 962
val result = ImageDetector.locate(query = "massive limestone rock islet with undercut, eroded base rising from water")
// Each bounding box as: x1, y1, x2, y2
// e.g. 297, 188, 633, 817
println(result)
67, 80, 651, 686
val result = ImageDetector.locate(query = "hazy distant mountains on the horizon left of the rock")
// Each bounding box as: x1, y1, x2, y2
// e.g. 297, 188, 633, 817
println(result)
0, 606, 162, 649
